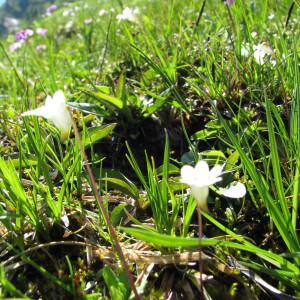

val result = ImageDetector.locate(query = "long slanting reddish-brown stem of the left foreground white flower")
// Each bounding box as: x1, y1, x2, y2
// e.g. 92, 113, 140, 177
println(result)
71, 117, 141, 300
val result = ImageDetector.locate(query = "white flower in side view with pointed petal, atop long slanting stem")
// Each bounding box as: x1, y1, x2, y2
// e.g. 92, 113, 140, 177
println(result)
22, 91, 72, 141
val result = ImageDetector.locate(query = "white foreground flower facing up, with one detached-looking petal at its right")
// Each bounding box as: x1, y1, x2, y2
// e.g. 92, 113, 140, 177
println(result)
181, 160, 246, 211
